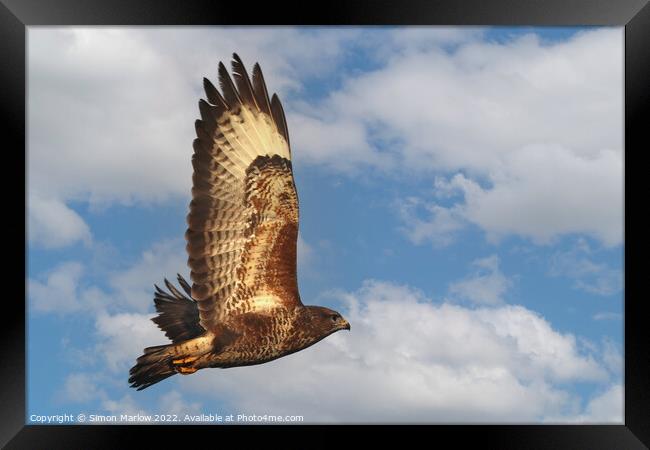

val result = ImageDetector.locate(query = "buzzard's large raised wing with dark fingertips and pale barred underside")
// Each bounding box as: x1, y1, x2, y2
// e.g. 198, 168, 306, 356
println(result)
185, 54, 302, 330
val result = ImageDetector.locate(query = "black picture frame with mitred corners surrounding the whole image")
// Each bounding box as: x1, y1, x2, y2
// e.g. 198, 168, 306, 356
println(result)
0, 0, 650, 449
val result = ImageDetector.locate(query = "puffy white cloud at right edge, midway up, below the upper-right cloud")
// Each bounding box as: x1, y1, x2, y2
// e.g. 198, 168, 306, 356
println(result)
430, 145, 623, 246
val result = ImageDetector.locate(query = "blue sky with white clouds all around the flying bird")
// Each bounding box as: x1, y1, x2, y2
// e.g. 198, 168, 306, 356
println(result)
26, 27, 624, 423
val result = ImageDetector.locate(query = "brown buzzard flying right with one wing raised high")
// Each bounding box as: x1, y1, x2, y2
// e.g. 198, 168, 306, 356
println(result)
129, 54, 350, 390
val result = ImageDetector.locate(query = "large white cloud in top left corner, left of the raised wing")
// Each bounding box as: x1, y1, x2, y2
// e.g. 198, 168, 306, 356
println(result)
28, 28, 192, 203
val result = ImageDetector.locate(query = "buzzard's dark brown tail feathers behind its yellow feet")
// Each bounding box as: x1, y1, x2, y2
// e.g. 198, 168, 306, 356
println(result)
129, 344, 177, 391
